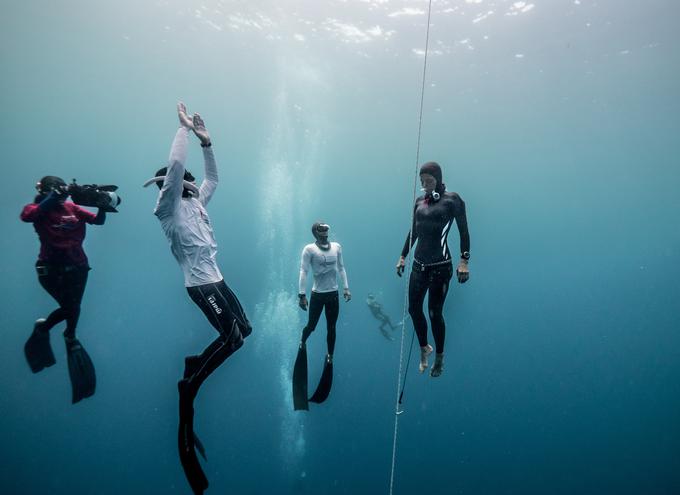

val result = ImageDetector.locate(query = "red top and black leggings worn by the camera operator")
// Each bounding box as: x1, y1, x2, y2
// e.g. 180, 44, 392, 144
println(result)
21, 193, 106, 338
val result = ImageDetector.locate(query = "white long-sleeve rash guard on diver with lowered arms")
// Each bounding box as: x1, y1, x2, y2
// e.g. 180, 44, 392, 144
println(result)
299, 242, 349, 294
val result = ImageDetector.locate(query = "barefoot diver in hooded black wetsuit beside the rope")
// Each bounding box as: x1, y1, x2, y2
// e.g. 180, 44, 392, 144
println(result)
397, 162, 470, 377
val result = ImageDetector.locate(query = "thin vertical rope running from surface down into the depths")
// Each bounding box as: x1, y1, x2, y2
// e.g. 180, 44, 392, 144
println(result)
389, 0, 432, 495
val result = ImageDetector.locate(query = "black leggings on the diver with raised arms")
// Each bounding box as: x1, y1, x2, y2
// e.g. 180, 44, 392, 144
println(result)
184, 280, 252, 395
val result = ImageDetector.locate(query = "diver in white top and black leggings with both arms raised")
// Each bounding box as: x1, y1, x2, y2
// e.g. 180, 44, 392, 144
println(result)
145, 102, 252, 494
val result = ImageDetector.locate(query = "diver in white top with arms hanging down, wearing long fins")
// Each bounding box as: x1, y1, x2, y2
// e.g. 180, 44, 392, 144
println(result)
293, 222, 352, 410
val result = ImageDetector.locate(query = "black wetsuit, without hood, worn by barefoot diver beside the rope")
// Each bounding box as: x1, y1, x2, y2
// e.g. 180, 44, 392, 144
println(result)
401, 192, 470, 353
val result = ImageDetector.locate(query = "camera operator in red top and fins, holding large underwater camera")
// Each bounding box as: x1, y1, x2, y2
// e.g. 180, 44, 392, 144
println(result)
21, 175, 120, 404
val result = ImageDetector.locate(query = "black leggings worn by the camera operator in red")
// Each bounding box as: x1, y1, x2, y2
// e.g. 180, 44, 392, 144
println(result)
35, 262, 90, 338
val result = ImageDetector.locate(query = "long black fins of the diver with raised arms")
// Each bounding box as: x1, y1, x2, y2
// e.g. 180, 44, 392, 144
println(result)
177, 380, 208, 495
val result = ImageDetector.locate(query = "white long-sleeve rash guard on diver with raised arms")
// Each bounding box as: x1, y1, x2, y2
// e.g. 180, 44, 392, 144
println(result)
154, 127, 222, 287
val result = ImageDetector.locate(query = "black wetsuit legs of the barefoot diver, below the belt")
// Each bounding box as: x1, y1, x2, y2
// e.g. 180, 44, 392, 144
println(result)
408, 263, 453, 353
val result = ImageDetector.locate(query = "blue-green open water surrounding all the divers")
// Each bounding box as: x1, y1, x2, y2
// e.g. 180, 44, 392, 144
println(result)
0, 0, 680, 495
